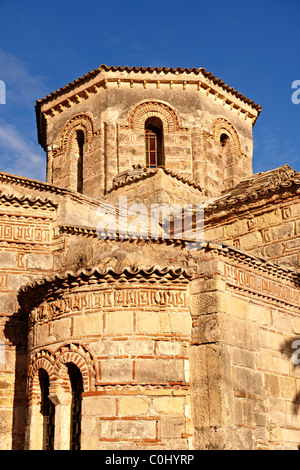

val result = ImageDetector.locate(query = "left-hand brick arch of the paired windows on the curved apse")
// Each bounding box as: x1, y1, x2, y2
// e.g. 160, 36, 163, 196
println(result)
28, 350, 55, 403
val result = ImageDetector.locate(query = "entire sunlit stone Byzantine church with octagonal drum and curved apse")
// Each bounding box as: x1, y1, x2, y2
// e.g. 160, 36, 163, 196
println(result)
0, 65, 300, 451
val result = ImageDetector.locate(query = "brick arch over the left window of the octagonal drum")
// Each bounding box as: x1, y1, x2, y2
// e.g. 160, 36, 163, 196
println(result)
60, 114, 95, 152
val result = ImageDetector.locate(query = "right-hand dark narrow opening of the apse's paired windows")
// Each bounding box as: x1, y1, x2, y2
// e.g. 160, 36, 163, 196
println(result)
68, 363, 83, 450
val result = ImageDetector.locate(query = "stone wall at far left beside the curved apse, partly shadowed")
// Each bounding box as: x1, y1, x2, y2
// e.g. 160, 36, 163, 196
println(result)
0, 195, 55, 450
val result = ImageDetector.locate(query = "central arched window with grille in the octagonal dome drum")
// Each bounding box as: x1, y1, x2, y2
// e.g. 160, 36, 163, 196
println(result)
145, 116, 164, 168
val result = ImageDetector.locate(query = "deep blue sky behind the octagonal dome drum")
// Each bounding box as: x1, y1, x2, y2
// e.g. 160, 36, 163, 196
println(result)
0, 0, 300, 180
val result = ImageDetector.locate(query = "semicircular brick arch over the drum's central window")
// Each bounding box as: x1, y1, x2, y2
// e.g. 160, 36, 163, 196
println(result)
128, 100, 181, 133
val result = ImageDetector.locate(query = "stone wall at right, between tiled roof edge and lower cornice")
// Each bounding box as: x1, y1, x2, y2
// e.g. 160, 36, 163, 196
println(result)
205, 194, 300, 267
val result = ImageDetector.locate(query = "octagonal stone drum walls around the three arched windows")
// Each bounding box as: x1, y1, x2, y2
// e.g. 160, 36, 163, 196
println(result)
38, 68, 257, 198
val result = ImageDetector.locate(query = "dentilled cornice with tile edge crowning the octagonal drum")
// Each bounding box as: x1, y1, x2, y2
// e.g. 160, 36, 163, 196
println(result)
35, 65, 261, 146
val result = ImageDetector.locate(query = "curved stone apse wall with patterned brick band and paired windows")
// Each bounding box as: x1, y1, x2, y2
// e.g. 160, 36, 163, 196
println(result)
23, 276, 191, 449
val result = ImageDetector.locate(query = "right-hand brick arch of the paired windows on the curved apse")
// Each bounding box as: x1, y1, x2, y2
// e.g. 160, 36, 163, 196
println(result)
53, 343, 97, 392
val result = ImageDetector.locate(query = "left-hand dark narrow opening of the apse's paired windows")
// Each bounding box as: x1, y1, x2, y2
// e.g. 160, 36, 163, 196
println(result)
39, 369, 55, 450
